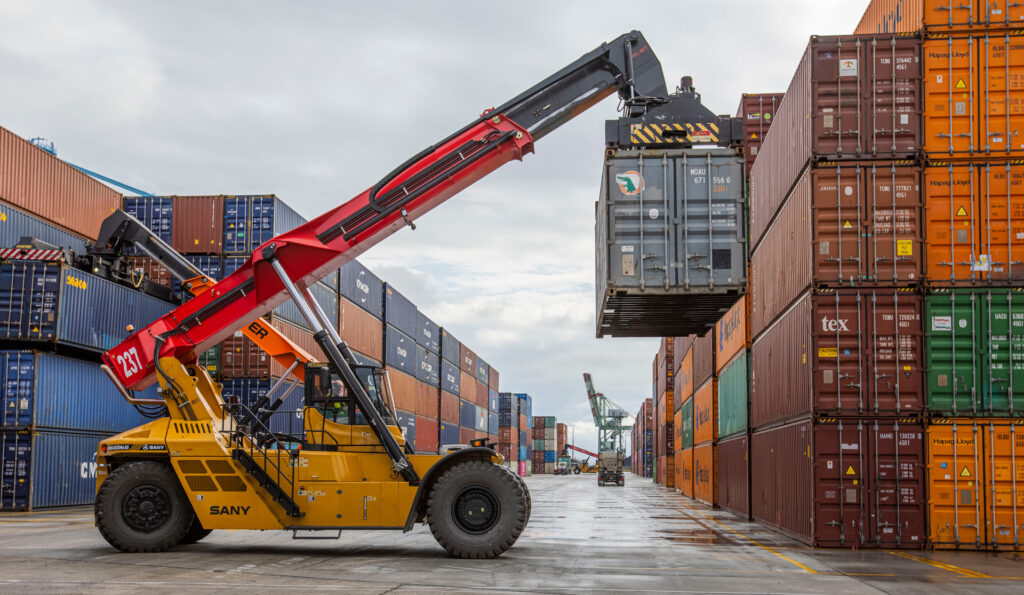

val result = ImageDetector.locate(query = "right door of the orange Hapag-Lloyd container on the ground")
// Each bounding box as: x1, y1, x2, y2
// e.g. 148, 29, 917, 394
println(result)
982, 420, 1024, 548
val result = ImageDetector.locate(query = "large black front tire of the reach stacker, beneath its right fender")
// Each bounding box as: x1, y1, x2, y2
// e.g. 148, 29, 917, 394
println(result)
427, 461, 530, 558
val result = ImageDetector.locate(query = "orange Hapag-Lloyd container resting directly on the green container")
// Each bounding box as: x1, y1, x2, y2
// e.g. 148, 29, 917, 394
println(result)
925, 160, 1024, 286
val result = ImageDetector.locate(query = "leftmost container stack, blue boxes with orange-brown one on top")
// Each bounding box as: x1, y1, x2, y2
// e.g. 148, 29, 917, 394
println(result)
0, 128, 173, 510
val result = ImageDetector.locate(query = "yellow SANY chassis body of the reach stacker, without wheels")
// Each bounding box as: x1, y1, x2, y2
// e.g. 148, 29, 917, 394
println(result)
96, 357, 503, 530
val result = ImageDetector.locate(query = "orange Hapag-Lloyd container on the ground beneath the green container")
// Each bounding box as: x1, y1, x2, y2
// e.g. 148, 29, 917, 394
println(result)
928, 418, 1024, 551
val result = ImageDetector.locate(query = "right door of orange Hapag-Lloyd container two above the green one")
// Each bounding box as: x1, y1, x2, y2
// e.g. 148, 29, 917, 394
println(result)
978, 30, 1024, 157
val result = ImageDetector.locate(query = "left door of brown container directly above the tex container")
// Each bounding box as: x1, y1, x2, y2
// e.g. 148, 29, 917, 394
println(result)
811, 162, 870, 287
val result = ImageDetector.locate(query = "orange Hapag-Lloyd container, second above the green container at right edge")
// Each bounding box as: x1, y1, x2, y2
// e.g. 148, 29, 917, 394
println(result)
923, 31, 1024, 159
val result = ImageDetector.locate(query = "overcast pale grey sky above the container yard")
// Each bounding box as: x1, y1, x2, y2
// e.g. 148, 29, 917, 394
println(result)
0, 0, 867, 449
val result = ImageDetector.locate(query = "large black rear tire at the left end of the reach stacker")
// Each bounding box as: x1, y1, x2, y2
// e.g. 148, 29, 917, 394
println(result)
95, 461, 196, 553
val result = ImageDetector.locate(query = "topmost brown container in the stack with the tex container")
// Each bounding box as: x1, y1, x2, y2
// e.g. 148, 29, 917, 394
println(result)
751, 35, 921, 246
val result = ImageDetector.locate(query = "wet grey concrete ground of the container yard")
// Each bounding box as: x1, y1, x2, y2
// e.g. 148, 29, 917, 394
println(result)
0, 475, 1024, 595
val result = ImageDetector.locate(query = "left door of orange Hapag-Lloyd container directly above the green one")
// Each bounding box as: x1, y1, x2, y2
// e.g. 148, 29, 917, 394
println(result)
925, 163, 987, 286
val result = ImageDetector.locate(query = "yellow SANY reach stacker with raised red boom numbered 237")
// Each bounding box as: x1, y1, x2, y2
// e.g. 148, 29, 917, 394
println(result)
95, 32, 726, 558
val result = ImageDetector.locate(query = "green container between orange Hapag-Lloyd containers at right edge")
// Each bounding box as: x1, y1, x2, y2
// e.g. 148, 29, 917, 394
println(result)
925, 289, 1024, 417
